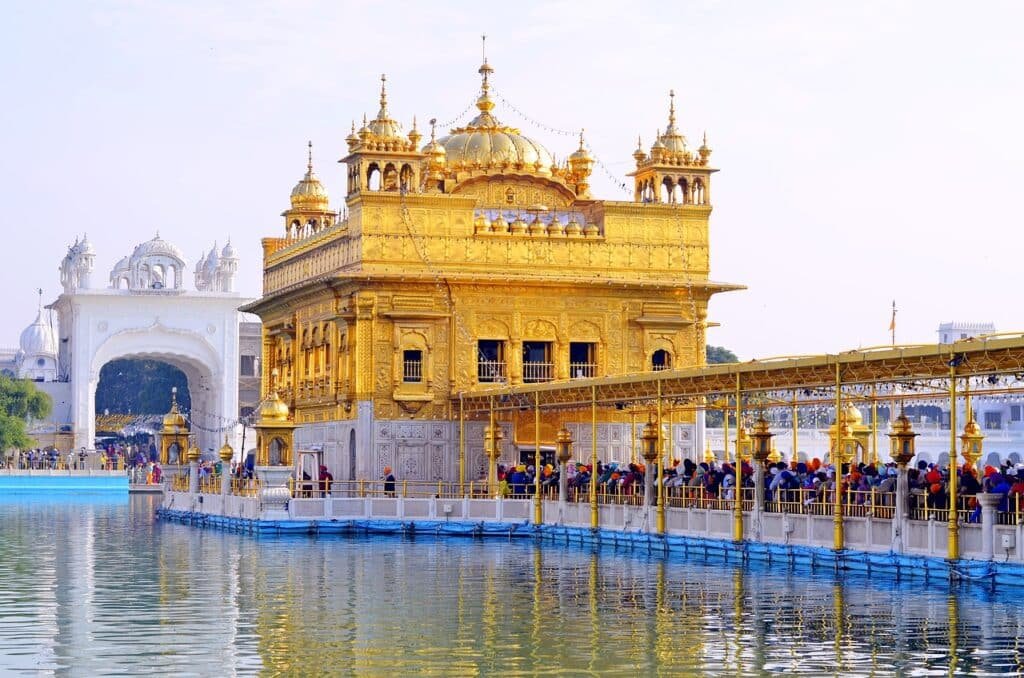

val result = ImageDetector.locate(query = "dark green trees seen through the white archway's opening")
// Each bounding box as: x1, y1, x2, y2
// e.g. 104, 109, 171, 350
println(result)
96, 358, 191, 415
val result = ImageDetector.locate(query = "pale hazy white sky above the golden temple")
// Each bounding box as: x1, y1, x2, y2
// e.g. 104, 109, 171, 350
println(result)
0, 0, 1024, 358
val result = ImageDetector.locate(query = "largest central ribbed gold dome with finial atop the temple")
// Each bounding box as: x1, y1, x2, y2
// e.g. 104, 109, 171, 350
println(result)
438, 61, 555, 176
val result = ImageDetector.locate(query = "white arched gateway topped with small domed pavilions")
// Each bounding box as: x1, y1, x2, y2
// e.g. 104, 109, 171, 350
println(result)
51, 236, 245, 458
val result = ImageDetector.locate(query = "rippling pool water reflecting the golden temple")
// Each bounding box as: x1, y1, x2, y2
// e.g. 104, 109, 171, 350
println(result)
0, 496, 1024, 675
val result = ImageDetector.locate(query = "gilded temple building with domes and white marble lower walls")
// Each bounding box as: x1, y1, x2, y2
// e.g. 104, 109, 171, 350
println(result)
244, 59, 739, 480
